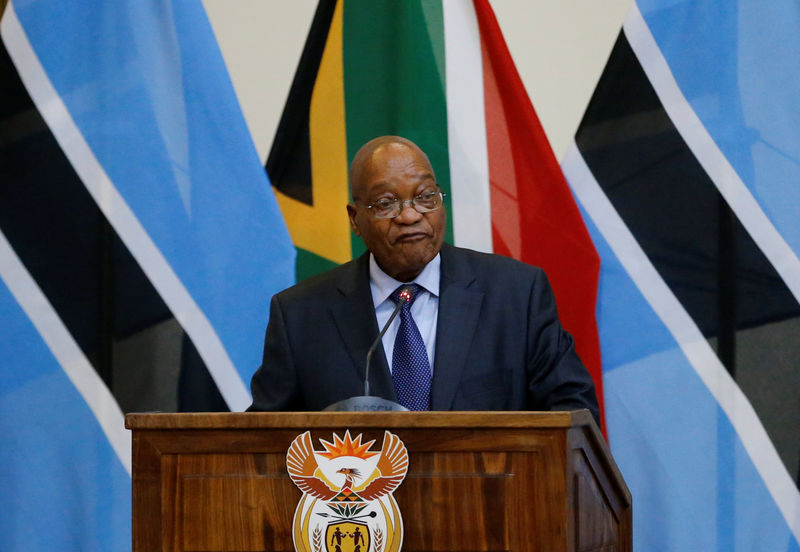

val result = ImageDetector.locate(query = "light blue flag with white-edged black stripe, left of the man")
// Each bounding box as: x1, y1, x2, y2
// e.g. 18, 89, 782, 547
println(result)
0, 0, 294, 551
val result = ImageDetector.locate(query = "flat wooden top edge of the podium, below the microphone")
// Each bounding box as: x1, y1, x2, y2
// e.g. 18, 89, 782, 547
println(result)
125, 410, 596, 430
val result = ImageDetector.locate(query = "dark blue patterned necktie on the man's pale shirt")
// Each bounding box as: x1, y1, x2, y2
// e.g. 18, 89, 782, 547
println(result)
389, 284, 431, 410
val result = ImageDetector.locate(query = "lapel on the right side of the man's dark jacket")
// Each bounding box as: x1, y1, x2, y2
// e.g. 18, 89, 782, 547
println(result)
432, 244, 483, 410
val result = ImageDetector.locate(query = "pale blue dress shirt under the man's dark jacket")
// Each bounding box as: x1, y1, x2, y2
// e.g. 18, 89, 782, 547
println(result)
369, 253, 442, 372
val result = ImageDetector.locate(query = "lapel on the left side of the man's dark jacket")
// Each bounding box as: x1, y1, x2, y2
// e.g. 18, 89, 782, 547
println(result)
331, 253, 397, 401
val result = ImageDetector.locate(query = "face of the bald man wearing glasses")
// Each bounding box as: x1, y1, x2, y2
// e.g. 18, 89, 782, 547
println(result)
347, 143, 447, 282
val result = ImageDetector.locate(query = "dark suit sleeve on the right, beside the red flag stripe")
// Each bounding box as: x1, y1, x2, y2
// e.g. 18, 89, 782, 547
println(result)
527, 271, 600, 426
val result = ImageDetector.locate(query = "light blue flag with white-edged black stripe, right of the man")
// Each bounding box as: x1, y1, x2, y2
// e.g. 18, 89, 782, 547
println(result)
562, 0, 800, 552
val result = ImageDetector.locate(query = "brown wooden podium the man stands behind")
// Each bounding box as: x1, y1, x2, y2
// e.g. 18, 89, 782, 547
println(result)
125, 410, 632, 552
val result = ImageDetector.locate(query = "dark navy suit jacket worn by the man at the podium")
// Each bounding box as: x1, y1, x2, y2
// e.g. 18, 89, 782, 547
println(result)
250, 244, 599, 423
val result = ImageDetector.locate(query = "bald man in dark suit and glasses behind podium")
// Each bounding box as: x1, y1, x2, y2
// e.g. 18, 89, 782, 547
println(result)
250, 136, 599, 419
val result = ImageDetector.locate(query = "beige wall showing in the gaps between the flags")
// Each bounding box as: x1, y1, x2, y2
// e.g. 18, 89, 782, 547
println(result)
203, 0, 633, 163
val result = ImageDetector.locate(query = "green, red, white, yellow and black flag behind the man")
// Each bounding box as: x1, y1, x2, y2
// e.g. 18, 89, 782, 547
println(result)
266, 0, 602, 422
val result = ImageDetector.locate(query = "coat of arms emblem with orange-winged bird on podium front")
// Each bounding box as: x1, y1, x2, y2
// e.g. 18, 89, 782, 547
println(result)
286, 430, 408, 552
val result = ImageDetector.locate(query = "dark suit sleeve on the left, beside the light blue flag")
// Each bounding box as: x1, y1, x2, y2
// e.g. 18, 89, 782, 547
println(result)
247, 295, 302, 411
